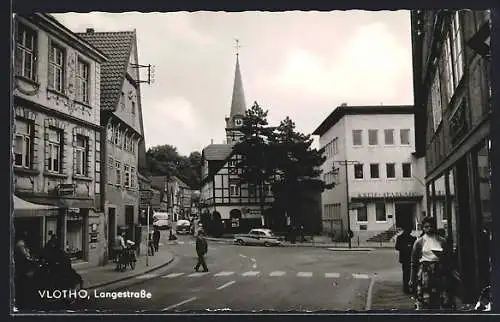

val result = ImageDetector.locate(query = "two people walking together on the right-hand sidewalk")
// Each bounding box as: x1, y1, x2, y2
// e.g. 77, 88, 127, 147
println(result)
395, 217, 454, 310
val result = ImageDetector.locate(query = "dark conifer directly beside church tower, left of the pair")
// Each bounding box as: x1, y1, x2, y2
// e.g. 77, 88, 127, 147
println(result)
234, 102, 274, 220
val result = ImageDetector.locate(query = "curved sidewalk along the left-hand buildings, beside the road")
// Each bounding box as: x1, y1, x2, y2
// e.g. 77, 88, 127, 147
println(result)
74, 243, 174, 289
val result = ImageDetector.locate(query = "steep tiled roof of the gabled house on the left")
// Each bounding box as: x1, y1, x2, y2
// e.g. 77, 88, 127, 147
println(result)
77, 31, 135, 111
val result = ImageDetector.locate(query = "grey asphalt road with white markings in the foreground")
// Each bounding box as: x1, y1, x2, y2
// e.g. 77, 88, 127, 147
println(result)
85, 236, 398, 313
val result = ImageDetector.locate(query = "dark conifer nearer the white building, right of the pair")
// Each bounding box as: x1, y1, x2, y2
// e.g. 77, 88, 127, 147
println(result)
270, 116, 329, 228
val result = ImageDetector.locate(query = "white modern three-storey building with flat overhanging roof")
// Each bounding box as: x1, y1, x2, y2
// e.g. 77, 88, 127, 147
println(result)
313, 104, 426, 241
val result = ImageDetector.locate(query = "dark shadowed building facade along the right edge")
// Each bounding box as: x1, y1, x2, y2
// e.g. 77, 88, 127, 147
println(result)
411, 10, 493, 303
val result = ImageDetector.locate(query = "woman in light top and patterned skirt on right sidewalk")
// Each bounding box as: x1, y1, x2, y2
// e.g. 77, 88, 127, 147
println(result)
409, 217, 452, 310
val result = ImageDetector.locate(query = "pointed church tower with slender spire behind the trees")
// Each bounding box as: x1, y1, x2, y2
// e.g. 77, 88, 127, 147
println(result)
226, 40, 246, 144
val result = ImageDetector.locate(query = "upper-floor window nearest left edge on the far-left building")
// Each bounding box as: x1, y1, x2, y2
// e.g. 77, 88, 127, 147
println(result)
15, 24, 37, 81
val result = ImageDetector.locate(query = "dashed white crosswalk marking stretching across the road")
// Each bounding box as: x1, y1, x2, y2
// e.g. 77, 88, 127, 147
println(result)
136, 270, 370, 279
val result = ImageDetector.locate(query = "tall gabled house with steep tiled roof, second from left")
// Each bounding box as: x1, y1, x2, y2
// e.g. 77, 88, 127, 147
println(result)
78, 28, 144, 256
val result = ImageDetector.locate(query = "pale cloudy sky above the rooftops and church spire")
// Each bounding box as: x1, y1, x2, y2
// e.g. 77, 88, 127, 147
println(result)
54, 10, 413, 156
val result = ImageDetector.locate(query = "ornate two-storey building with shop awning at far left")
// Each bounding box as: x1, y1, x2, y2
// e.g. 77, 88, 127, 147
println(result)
12, 14, 107, 266
